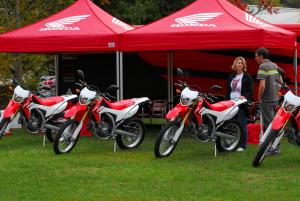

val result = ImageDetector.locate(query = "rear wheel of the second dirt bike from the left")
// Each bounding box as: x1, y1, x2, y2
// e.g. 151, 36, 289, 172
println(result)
116, 118, 145, 149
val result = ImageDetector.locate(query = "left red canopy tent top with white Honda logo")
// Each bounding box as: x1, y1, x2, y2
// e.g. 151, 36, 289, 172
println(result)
0, 0, 134, 53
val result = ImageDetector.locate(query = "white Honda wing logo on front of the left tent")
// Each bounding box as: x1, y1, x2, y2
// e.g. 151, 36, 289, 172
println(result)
39, 15, 90, 31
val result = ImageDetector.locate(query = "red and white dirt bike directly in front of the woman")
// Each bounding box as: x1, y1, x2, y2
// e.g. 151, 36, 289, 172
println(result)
154, 69, 247, 158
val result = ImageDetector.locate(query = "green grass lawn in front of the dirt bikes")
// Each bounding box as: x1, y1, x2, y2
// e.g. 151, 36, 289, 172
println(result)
0, 130, 300, 201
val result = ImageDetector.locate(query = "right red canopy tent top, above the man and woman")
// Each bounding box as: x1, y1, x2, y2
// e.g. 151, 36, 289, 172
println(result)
121, 0, 296, 51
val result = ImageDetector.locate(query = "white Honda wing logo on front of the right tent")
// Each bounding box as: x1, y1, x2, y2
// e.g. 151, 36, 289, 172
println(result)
171, 13, 223, 27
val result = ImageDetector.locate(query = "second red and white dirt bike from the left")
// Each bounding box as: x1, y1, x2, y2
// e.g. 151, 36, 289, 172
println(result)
53, 70, 149, 154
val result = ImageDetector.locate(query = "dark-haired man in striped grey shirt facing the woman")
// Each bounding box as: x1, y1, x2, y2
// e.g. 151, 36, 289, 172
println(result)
255, 47, 282, 154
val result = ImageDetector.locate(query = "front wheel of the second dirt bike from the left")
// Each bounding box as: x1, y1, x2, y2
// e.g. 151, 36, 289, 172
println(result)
53, 119, 80, 154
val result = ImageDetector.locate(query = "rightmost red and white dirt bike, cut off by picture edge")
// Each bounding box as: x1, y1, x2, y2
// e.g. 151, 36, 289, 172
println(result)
252, 81, 300, 167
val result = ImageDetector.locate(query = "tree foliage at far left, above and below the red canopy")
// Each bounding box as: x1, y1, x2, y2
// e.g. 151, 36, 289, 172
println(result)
0, 0, 74, 87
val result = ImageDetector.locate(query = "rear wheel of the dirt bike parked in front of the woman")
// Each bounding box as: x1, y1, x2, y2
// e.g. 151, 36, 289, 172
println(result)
216, 121, 242, 152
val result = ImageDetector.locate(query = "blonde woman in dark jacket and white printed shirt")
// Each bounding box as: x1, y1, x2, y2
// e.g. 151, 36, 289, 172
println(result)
226, 57, 253, 152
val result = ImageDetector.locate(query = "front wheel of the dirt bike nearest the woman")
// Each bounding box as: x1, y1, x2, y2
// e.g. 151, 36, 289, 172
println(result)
154, 121, 180, 158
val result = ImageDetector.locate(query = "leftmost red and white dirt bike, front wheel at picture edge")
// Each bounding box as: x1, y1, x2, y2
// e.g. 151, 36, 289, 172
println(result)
0, 68, 78, 142
